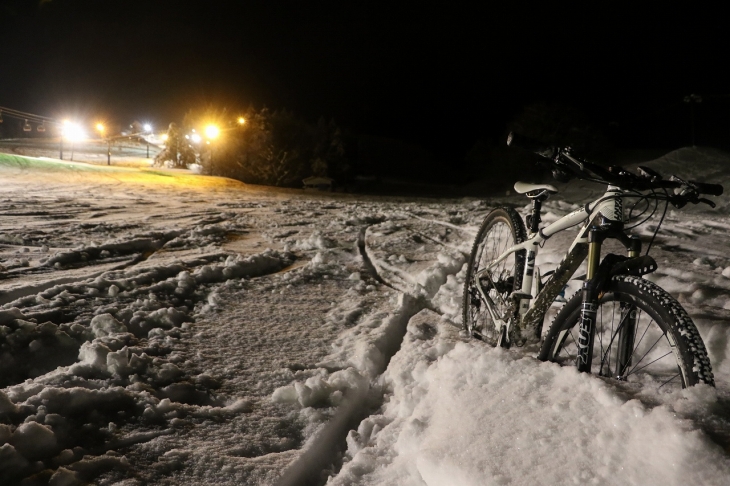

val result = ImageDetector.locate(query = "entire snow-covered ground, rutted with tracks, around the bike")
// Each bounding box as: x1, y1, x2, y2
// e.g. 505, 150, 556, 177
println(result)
0, 149, 730, 485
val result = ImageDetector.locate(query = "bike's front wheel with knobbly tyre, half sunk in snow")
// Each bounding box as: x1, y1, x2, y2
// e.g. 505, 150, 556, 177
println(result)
538, 275, 715, 391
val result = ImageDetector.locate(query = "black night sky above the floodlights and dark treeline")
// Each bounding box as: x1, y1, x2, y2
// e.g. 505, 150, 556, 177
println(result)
0, 0, 730, 160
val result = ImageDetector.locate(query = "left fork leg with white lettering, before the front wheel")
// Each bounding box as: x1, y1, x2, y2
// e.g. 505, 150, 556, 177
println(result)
576, 227, 602, 373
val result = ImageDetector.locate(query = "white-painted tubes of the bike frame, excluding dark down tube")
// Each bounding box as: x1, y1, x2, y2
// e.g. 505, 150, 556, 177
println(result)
475, 185, 623, 334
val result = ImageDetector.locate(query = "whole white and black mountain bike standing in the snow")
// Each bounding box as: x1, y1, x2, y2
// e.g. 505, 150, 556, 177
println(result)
463, 133, 723, 390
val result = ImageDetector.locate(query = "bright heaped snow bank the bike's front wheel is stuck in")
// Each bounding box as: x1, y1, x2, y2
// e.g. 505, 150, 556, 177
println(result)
328, 315, 730, 485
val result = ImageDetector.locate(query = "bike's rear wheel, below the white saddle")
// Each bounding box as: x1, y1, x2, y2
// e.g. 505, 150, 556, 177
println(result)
463, 208, 526, 346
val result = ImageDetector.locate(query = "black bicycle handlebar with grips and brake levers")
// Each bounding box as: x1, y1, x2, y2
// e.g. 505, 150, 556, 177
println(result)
507, 132, 723, 199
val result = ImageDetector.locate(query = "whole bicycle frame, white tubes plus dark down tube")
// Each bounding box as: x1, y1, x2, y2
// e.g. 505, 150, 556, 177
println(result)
475, 185, 623, 339
